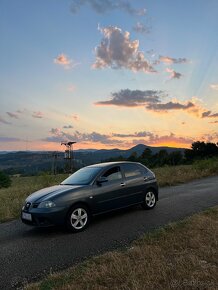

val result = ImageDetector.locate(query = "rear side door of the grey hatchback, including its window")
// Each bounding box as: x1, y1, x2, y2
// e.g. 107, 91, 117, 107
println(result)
119, 163, 146, 206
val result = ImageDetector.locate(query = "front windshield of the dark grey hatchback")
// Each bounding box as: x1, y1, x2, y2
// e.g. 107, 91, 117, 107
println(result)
61, 167, 101, 185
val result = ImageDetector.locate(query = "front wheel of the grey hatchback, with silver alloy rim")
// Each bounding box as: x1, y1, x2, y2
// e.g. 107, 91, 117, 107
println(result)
66, 204, 90, 233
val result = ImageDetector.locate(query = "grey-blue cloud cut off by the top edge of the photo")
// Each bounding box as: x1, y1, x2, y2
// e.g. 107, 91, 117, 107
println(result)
71, 0, 146, 16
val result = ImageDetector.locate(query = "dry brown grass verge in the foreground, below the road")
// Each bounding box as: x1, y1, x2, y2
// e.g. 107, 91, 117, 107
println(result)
25, 207, 218, 290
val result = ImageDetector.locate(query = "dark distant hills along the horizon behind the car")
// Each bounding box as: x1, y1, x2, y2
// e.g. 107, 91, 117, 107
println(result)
0, 144, 184, 175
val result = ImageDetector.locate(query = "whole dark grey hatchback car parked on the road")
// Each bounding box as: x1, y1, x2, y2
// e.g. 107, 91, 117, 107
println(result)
21, 161, 158, 232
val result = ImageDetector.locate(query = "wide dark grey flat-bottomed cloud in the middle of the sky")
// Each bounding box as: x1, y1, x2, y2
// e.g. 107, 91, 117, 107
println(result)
95, 89, 164, 107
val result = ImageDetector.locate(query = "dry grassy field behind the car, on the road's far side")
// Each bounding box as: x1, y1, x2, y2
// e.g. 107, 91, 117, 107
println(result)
0, 159, 218, 222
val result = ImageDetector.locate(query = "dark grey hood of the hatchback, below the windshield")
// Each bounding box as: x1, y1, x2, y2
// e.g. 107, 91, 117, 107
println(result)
26, 185, 85, 203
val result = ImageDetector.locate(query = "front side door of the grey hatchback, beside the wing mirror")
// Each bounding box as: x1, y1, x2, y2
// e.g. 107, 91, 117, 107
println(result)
92, 166, 125, 214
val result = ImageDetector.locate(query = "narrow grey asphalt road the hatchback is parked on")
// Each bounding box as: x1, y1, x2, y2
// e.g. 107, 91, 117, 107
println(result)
0, 176, 218, 289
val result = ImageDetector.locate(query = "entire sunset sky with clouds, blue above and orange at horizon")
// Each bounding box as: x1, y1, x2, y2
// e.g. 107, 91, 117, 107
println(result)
0, 0, 218, 150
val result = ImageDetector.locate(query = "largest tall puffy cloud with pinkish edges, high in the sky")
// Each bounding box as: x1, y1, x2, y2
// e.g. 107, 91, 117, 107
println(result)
92, 26, 156, 73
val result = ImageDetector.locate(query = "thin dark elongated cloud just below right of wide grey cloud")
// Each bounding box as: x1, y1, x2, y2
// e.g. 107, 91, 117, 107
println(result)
146, 102, 195, 111
